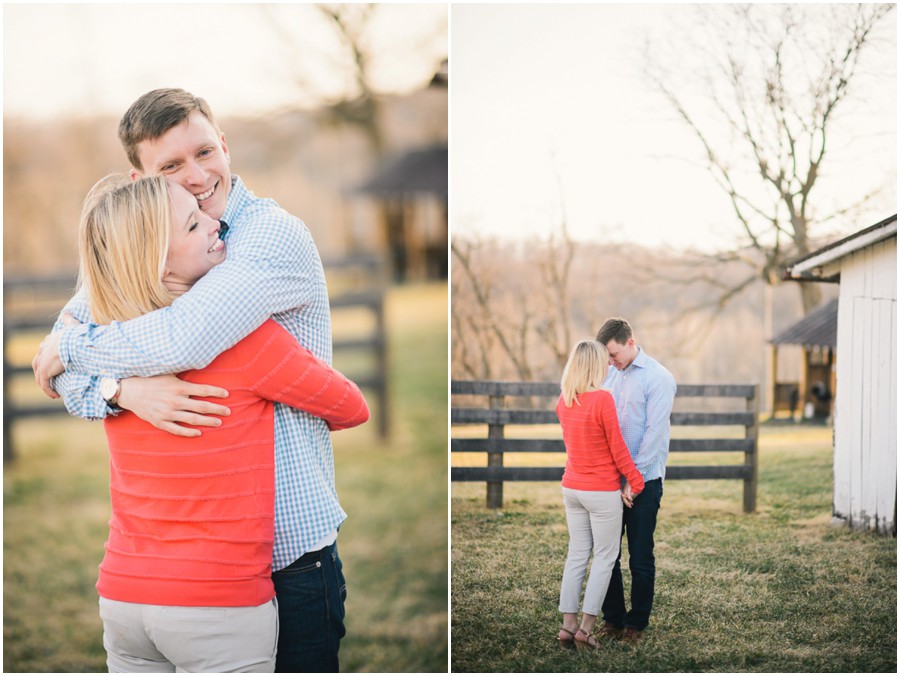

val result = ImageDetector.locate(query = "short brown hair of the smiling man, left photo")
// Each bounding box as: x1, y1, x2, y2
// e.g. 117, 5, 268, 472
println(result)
119, 89, 222, 171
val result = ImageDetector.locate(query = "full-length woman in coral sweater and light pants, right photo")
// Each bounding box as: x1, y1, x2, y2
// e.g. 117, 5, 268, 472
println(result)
556, 340, 644, 649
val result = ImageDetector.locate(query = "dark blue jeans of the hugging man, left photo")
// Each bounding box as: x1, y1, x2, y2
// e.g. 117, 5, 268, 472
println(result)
272, 543, 347, 673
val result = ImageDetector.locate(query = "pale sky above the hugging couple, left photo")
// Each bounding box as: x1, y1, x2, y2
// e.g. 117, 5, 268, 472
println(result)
3, 3, 448, 117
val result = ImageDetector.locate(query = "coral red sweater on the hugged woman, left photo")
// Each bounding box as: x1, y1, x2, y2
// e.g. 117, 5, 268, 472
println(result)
97, 320, 369, 606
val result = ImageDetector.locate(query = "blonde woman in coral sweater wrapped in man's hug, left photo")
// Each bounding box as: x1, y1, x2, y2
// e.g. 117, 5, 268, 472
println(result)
79, 176, 369, 672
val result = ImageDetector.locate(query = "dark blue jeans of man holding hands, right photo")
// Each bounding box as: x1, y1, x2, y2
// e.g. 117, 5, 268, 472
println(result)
603, 479, 662, 631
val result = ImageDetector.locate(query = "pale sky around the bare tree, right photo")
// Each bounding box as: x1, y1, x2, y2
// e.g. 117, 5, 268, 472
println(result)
450, 4, 897, 250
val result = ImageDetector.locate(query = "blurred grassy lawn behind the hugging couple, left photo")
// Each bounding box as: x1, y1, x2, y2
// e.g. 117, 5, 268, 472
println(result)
3, 285, 448, 673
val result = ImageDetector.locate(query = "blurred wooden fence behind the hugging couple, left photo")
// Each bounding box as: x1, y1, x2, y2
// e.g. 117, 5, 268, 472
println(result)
3, 256, 390, 461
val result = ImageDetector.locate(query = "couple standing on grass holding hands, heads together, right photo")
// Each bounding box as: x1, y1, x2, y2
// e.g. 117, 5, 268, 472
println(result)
556, 317, 676, 649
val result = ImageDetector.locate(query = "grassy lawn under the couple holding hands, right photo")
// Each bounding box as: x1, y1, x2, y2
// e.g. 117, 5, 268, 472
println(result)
451, 426, 897, 673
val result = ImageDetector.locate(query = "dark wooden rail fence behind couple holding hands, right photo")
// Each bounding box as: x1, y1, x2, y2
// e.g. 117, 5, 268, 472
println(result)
450, 380, 759, 513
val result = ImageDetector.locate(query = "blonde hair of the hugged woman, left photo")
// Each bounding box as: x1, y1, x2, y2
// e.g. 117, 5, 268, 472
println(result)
78, 174, 175, 324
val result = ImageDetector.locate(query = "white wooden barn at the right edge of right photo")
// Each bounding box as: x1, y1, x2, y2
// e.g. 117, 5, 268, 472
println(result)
785, 214, 897, 536
